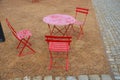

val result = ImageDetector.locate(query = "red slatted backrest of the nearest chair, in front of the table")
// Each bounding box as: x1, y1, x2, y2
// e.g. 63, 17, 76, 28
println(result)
45, 35, 72, 44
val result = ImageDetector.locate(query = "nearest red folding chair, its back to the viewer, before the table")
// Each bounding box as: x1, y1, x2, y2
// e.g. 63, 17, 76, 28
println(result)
45, 35, 72, 71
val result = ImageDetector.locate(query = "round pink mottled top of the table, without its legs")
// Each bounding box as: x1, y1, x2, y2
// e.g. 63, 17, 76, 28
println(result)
43, 14, 75, 26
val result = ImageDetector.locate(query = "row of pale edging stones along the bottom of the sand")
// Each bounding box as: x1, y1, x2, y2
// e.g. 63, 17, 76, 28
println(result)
9, 74, 113, 80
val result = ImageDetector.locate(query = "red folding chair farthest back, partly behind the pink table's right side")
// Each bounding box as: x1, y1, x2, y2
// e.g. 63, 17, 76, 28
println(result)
72, 7, 89, 39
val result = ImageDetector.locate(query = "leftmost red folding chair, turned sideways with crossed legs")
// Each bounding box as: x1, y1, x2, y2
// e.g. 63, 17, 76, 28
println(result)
6, 18, 35, 56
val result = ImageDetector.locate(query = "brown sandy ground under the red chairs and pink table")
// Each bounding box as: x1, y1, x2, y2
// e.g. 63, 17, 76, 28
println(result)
0, 0, 110, 78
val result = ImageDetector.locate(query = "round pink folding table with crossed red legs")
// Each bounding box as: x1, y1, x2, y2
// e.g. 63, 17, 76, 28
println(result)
43, 14, 76, 35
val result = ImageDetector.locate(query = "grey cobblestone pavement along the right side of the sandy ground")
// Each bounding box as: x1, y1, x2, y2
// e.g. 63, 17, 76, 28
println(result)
92, 0, 120, 80
